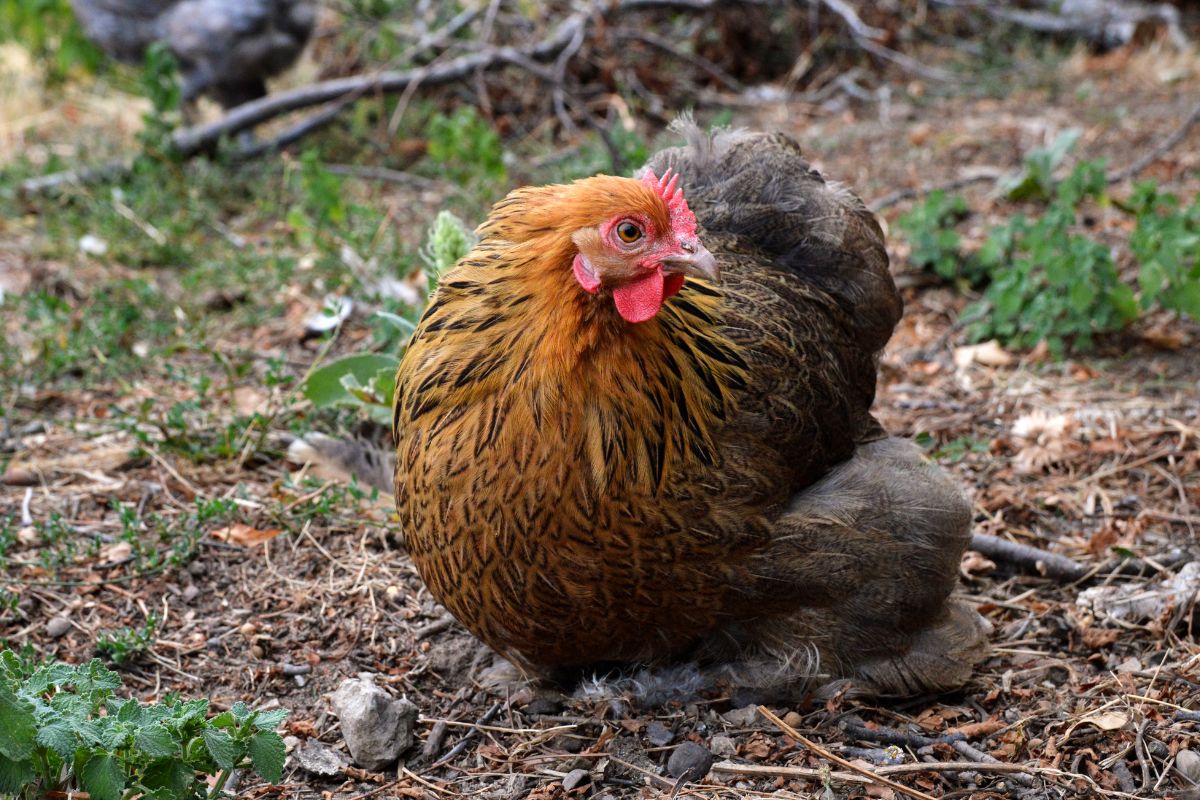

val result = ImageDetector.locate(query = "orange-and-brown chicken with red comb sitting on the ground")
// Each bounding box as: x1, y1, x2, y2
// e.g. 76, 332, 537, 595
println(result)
394, 124, 988, 694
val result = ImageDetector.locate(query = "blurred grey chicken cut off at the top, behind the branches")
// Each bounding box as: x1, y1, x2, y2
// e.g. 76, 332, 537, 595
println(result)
71, 0, 317, 108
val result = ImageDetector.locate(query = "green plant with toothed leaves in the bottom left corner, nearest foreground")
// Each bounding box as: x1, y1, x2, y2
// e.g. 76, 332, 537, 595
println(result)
0, 650, 288, 800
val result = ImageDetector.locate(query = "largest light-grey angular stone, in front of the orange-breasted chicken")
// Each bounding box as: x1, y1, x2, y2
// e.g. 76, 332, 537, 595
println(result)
330, 674, 416, 772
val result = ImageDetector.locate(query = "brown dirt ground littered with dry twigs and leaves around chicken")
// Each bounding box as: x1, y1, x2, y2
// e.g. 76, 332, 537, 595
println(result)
0, 28, 1200, 800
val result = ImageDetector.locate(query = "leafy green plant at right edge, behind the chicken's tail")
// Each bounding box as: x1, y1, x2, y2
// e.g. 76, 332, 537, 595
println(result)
898, 140, 1200, 356
